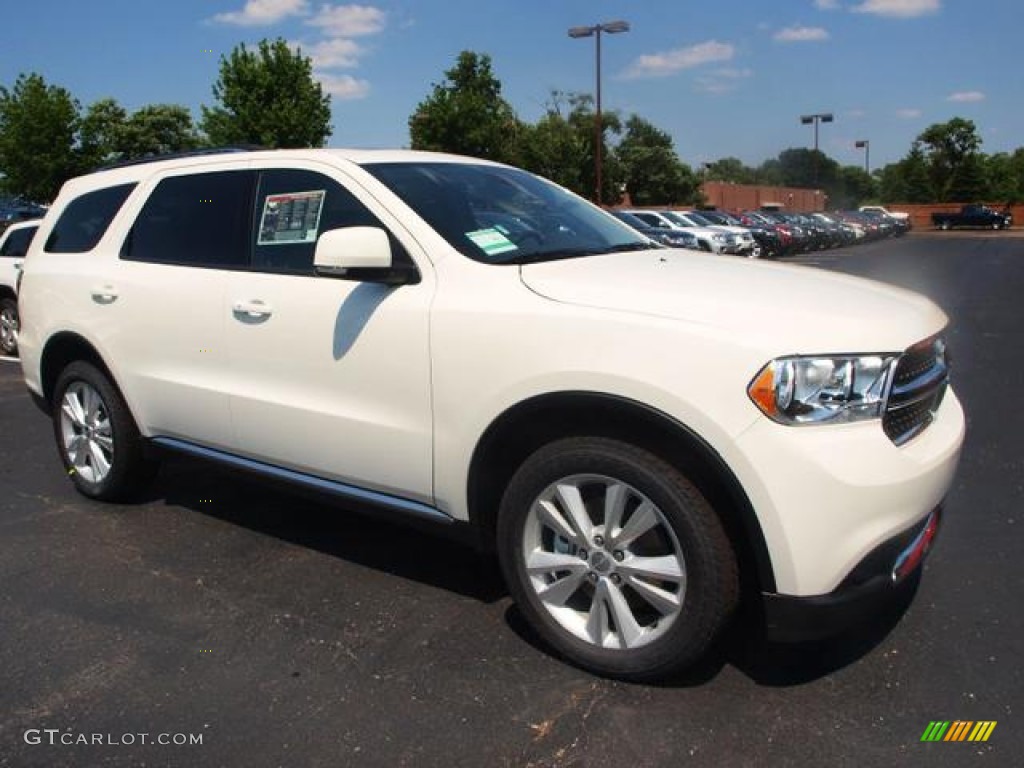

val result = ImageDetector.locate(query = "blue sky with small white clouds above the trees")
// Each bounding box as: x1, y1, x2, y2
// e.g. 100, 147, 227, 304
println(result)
0, 0, 1024, 168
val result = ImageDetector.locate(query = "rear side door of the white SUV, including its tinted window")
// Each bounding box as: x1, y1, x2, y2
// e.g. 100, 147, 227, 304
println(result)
110, 163, 256, 449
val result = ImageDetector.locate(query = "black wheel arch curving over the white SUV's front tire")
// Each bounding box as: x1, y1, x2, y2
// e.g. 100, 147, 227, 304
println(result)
467, 392, 775, 592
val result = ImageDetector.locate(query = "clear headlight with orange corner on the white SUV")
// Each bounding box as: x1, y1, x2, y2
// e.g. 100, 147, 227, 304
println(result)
746, 352, 898, 425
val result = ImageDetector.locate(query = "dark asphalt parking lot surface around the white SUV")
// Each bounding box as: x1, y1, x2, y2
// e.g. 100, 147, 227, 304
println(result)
0, 232, 1024, 768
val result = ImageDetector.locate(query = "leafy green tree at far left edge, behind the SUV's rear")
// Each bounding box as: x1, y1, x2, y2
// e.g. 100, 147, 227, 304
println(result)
0, 74, 79, 202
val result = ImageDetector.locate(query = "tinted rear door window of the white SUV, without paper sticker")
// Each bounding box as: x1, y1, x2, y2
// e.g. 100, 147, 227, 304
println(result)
121, 171, 256, 268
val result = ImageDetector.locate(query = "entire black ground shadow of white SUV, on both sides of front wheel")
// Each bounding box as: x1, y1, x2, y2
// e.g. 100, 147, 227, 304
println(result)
141, 457, 919, 688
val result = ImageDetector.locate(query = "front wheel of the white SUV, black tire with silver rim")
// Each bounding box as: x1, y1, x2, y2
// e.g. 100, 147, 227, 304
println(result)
498, 437, 739, 681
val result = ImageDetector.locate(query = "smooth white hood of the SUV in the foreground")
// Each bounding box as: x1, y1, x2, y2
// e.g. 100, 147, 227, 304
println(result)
520, 250, 947, 354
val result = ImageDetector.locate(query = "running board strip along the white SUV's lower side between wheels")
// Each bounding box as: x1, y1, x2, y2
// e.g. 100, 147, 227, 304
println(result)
151, 437, 455, 523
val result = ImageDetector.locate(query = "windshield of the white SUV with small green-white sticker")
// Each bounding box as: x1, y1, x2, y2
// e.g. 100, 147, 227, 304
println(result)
364, 162, 662, 264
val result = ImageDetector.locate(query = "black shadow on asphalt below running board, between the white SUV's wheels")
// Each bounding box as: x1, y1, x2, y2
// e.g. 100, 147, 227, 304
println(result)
149, 457, 508, 603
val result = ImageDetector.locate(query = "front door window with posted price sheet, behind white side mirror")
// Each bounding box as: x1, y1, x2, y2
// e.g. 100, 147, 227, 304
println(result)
253, 169, 399, 275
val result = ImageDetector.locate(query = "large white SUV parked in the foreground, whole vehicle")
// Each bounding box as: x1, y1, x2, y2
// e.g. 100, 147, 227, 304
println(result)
22, 150, 964, 679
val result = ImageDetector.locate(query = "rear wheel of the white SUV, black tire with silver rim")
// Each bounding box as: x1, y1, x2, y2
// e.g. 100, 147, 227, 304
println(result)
52, 360, 158, 502
